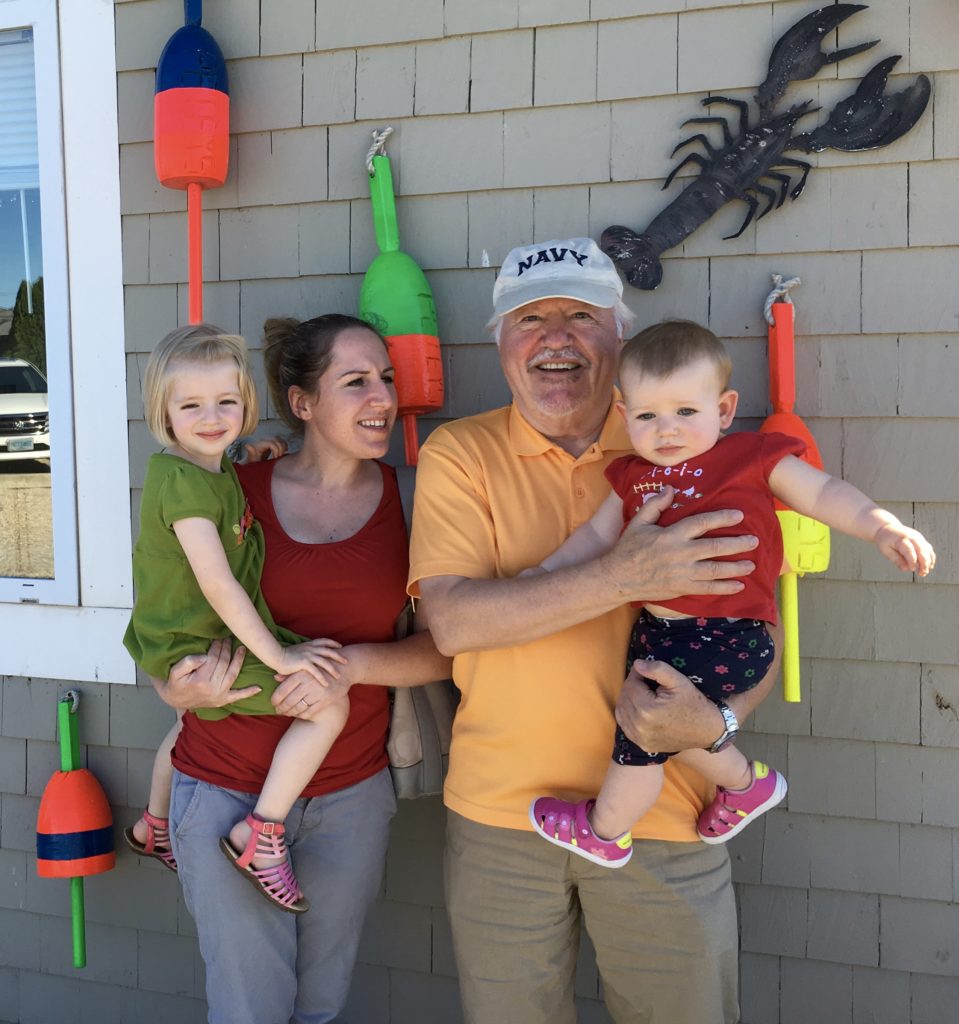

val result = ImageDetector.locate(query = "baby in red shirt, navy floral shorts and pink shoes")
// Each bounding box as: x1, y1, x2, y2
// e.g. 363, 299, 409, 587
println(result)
526, 321, 935, 867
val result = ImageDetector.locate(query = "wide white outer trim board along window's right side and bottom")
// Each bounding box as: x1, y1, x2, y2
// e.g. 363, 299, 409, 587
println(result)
0, 0, 136, 683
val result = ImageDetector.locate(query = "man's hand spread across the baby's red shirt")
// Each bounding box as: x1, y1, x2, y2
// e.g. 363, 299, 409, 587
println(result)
603, 487, 758, 602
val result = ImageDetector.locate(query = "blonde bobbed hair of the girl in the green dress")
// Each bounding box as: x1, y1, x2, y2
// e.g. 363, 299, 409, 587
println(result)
143, 324, 260, 446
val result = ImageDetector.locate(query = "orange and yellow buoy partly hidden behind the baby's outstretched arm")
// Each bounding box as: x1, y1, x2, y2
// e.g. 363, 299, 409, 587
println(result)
759, 273, 829, 703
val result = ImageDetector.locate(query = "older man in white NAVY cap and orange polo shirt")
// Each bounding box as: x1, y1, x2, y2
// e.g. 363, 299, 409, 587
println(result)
409, 239, 772, 1024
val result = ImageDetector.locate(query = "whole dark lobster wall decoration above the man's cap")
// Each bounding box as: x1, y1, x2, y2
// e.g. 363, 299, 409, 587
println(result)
600, 3, 930, 291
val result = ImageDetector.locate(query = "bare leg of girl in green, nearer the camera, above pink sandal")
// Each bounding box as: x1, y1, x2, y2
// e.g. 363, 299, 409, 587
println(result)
229, 694, 350, 868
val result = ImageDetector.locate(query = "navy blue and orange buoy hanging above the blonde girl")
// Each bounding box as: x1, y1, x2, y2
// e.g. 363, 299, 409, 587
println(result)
154, 0, 229, 324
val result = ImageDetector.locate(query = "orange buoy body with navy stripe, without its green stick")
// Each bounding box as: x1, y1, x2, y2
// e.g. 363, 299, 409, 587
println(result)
37, 768, 117, 879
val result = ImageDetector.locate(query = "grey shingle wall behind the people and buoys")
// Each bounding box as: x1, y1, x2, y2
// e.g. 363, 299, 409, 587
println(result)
0, 0, 959, 1024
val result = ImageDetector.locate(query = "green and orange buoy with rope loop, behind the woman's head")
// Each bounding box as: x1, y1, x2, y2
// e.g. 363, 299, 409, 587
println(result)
359, 128, 443, 466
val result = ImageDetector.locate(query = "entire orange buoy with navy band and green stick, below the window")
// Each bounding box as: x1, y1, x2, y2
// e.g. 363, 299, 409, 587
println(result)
37, 690, 117, 967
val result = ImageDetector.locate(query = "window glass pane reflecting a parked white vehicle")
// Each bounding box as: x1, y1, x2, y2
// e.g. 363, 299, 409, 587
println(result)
0, 29, 53, 579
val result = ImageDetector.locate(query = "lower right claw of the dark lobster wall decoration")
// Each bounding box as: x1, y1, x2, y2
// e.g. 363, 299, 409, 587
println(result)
788, 55, 931, 153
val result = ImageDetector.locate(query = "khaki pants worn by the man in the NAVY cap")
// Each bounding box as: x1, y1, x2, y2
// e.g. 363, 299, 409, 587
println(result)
446, 812, 739, 1024
